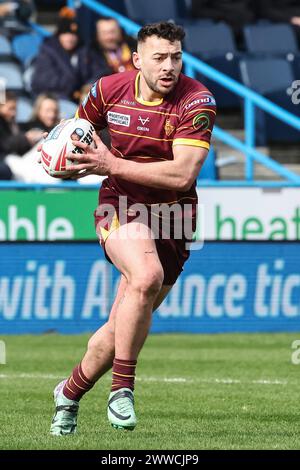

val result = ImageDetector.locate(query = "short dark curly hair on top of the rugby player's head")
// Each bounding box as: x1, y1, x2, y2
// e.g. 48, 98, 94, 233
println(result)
137, 21, 185, 43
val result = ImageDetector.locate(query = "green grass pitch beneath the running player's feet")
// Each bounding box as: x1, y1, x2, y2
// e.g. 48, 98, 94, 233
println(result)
0, 333, 300, 450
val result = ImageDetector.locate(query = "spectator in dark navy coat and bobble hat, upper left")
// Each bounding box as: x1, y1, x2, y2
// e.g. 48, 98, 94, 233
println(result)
32, 8, 98, 100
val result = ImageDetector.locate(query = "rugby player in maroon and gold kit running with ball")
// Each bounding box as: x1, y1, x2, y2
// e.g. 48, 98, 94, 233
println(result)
51, 22, 216, 435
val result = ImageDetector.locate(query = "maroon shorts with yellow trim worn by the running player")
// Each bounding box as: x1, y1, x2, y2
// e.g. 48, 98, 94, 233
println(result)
94, 187, 196, 285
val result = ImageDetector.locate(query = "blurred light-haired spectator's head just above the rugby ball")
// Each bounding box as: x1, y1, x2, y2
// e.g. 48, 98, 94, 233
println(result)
23, 93, 59, 132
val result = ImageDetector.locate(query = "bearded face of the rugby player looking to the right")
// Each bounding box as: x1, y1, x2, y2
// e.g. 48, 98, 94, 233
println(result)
133, 36, 182, 96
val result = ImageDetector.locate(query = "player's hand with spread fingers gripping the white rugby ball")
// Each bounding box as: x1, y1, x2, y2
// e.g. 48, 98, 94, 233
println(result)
67, 132, 115, 179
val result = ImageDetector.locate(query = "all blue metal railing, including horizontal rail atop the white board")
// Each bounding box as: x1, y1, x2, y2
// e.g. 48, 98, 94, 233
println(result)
0, 0, 300, 190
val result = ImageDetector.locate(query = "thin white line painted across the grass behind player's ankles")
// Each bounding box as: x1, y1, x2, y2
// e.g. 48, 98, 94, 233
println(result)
0, 373, 288, 385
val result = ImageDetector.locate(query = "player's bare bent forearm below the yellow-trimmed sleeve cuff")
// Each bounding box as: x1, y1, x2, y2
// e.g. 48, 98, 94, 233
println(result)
111, 158, 191, 191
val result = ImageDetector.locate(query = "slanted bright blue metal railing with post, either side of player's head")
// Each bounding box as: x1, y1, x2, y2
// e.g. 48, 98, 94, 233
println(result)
68, 0, 300, 184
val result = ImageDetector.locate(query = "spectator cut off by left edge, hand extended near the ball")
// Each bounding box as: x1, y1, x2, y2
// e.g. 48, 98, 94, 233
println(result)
0, 91, 42, 179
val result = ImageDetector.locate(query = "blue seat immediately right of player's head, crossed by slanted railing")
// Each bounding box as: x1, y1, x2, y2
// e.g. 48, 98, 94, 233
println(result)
185, 22, 241, 108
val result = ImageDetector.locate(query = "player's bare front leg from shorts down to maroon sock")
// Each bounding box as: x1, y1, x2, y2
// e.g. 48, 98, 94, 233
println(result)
106, 223, 163, 360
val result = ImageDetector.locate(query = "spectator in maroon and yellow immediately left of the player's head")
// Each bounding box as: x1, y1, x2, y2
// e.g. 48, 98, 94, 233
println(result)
88, 18, 135, 79
